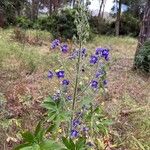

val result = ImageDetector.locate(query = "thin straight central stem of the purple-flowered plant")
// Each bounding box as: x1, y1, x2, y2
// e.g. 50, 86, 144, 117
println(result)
70, 42, 82, 136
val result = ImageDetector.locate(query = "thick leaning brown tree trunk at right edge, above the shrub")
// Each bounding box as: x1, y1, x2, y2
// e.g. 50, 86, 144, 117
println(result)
135, 0, 150, 56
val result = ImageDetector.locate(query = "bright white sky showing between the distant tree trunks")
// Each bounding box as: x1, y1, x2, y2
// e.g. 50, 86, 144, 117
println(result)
89, 0, 113, 12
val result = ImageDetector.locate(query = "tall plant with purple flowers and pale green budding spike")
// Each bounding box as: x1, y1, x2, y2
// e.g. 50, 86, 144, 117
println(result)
14, 3, 110, 150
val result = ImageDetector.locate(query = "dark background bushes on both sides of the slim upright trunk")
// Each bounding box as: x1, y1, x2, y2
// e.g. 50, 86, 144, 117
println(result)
90, 13, 140, 37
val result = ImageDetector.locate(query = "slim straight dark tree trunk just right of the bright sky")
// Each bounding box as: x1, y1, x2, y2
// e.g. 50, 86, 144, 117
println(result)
116, 0, 122, 36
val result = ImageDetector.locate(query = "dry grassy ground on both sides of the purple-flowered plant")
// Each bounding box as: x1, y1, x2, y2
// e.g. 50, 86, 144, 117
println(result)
0, 29, 150, 150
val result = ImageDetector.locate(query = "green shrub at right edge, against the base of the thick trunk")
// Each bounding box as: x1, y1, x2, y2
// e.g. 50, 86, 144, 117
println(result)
135, 41, 150, 73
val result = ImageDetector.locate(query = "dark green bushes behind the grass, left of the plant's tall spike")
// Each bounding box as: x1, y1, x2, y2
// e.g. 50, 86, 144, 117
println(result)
16, 8, 77, 39
